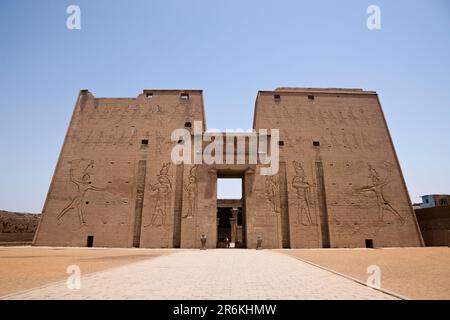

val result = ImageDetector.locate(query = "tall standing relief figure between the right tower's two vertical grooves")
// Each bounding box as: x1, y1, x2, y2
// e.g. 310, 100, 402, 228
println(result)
292, 160, 315, 226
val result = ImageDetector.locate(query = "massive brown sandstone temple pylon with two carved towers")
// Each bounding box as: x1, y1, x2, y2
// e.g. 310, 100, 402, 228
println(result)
34, 88, 423, 248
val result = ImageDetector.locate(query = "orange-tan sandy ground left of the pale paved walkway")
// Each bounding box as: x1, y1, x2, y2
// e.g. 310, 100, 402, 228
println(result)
0, 247, 179, 296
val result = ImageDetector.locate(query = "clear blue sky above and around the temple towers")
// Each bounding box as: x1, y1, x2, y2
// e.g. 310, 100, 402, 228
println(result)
0, 0, 450, 212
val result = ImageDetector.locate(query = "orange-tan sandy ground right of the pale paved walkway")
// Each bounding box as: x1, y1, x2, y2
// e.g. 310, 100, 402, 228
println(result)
277, 247, 450, 300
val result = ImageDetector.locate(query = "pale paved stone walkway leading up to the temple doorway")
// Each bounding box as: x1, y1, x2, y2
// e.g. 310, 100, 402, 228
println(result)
4, 249, 393, 299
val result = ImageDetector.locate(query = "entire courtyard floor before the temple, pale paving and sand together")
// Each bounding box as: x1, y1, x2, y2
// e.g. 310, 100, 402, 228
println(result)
0, 247, 450, 299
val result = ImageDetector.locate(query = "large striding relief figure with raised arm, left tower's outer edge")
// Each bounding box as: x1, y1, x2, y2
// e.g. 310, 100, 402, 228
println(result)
57, 160, 106, 226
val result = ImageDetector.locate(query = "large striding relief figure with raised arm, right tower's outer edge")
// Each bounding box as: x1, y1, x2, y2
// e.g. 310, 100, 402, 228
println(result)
357, 163, 406, 223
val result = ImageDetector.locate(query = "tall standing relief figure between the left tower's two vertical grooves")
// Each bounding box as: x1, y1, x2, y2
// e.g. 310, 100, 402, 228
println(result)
145, 162, 172, 227
